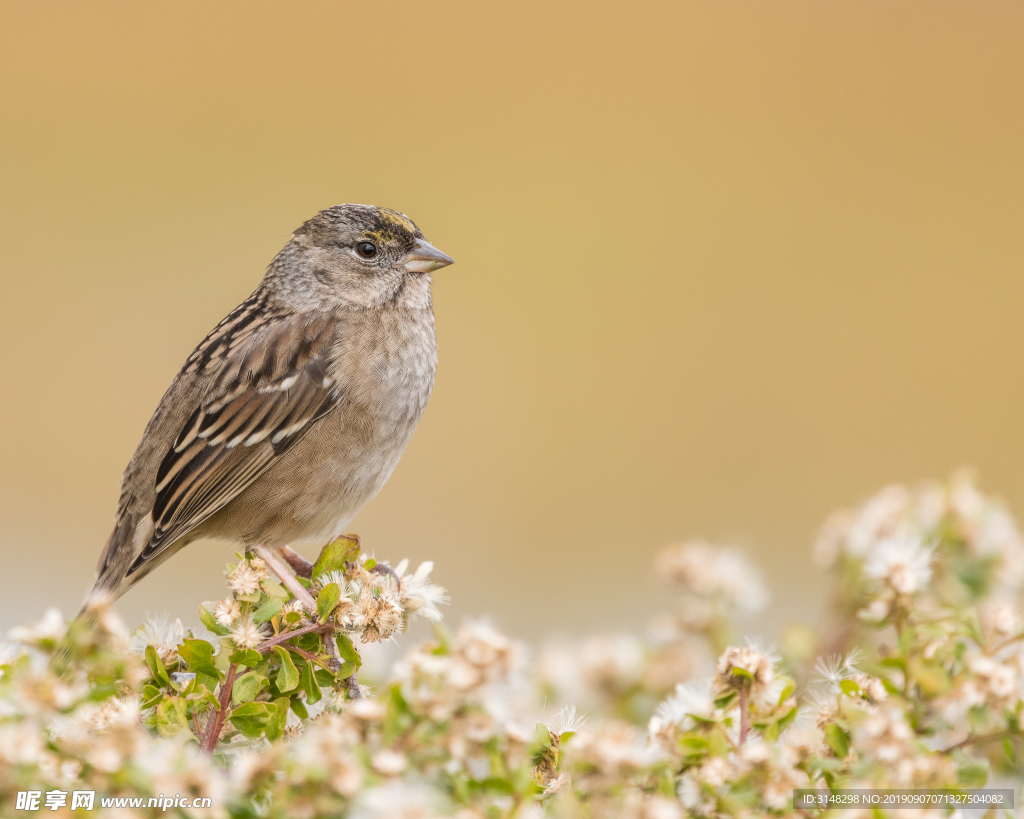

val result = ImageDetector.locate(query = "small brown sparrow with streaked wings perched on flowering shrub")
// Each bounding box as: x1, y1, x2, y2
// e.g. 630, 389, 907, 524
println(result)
83, 205, 454, 611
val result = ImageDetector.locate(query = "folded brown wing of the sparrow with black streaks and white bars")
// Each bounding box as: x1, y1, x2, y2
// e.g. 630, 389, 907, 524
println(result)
126, 316, 341, 577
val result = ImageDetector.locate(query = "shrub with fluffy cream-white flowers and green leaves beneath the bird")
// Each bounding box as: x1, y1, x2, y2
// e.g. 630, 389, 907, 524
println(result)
0, 475, 1024, 819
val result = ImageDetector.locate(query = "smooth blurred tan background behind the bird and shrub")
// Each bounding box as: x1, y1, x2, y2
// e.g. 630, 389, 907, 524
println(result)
0, 0, 1024, 636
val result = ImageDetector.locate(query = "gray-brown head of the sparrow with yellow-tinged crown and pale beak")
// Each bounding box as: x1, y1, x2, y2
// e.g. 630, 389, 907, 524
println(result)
265, 205, 455, 309
